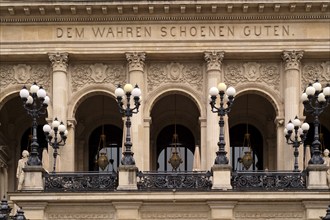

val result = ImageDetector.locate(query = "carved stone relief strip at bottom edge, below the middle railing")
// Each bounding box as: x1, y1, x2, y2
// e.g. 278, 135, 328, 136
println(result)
141, 211, 209, 220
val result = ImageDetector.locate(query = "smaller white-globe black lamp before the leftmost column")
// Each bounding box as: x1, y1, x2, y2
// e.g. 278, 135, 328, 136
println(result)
42, 118, 68, 172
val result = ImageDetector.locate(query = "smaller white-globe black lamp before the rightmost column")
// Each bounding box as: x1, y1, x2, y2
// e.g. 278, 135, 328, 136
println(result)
284, 116, 309, 172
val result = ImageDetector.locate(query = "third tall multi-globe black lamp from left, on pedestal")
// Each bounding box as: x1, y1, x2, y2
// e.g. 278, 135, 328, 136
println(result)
209, 83, 236, 164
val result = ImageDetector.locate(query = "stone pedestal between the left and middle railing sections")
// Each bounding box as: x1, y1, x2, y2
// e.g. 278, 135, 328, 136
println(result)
117, 165, 138, 190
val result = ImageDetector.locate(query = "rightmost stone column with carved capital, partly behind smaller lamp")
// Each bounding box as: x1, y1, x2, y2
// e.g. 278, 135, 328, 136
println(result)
278, 51, 303, 170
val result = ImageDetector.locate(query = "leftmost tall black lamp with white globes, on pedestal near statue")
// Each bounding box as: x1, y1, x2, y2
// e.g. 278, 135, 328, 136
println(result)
19, 83, 49, 166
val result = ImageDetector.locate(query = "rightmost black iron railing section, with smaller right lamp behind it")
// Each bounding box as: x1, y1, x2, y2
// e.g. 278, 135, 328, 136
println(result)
231, 171, 306, 191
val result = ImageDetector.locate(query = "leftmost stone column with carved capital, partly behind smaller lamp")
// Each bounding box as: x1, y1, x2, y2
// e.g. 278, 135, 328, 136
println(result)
48, 52, 74, 172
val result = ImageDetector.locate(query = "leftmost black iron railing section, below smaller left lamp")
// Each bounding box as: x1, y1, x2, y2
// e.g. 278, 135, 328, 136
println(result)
44, 172, 118, 192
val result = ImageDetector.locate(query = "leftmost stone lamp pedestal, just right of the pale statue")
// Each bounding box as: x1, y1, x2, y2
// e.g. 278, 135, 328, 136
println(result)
22, 166, 46, 191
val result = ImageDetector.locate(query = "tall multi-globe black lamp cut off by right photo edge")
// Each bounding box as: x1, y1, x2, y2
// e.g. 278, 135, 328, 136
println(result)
301, 80, 330, 164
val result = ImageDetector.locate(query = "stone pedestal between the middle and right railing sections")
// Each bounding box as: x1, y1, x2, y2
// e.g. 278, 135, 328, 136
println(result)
212, 164, 233, 190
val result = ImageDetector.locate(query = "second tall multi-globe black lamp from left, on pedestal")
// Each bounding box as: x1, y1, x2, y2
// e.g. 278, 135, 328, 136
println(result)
115, 84, 141, 165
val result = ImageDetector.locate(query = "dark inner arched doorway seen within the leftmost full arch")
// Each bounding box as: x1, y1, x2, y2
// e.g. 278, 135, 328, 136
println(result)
88, 124, 123, 172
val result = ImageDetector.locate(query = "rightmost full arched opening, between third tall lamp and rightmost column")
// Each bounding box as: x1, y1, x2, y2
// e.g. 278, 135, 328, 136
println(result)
229, 91, 277, 170
